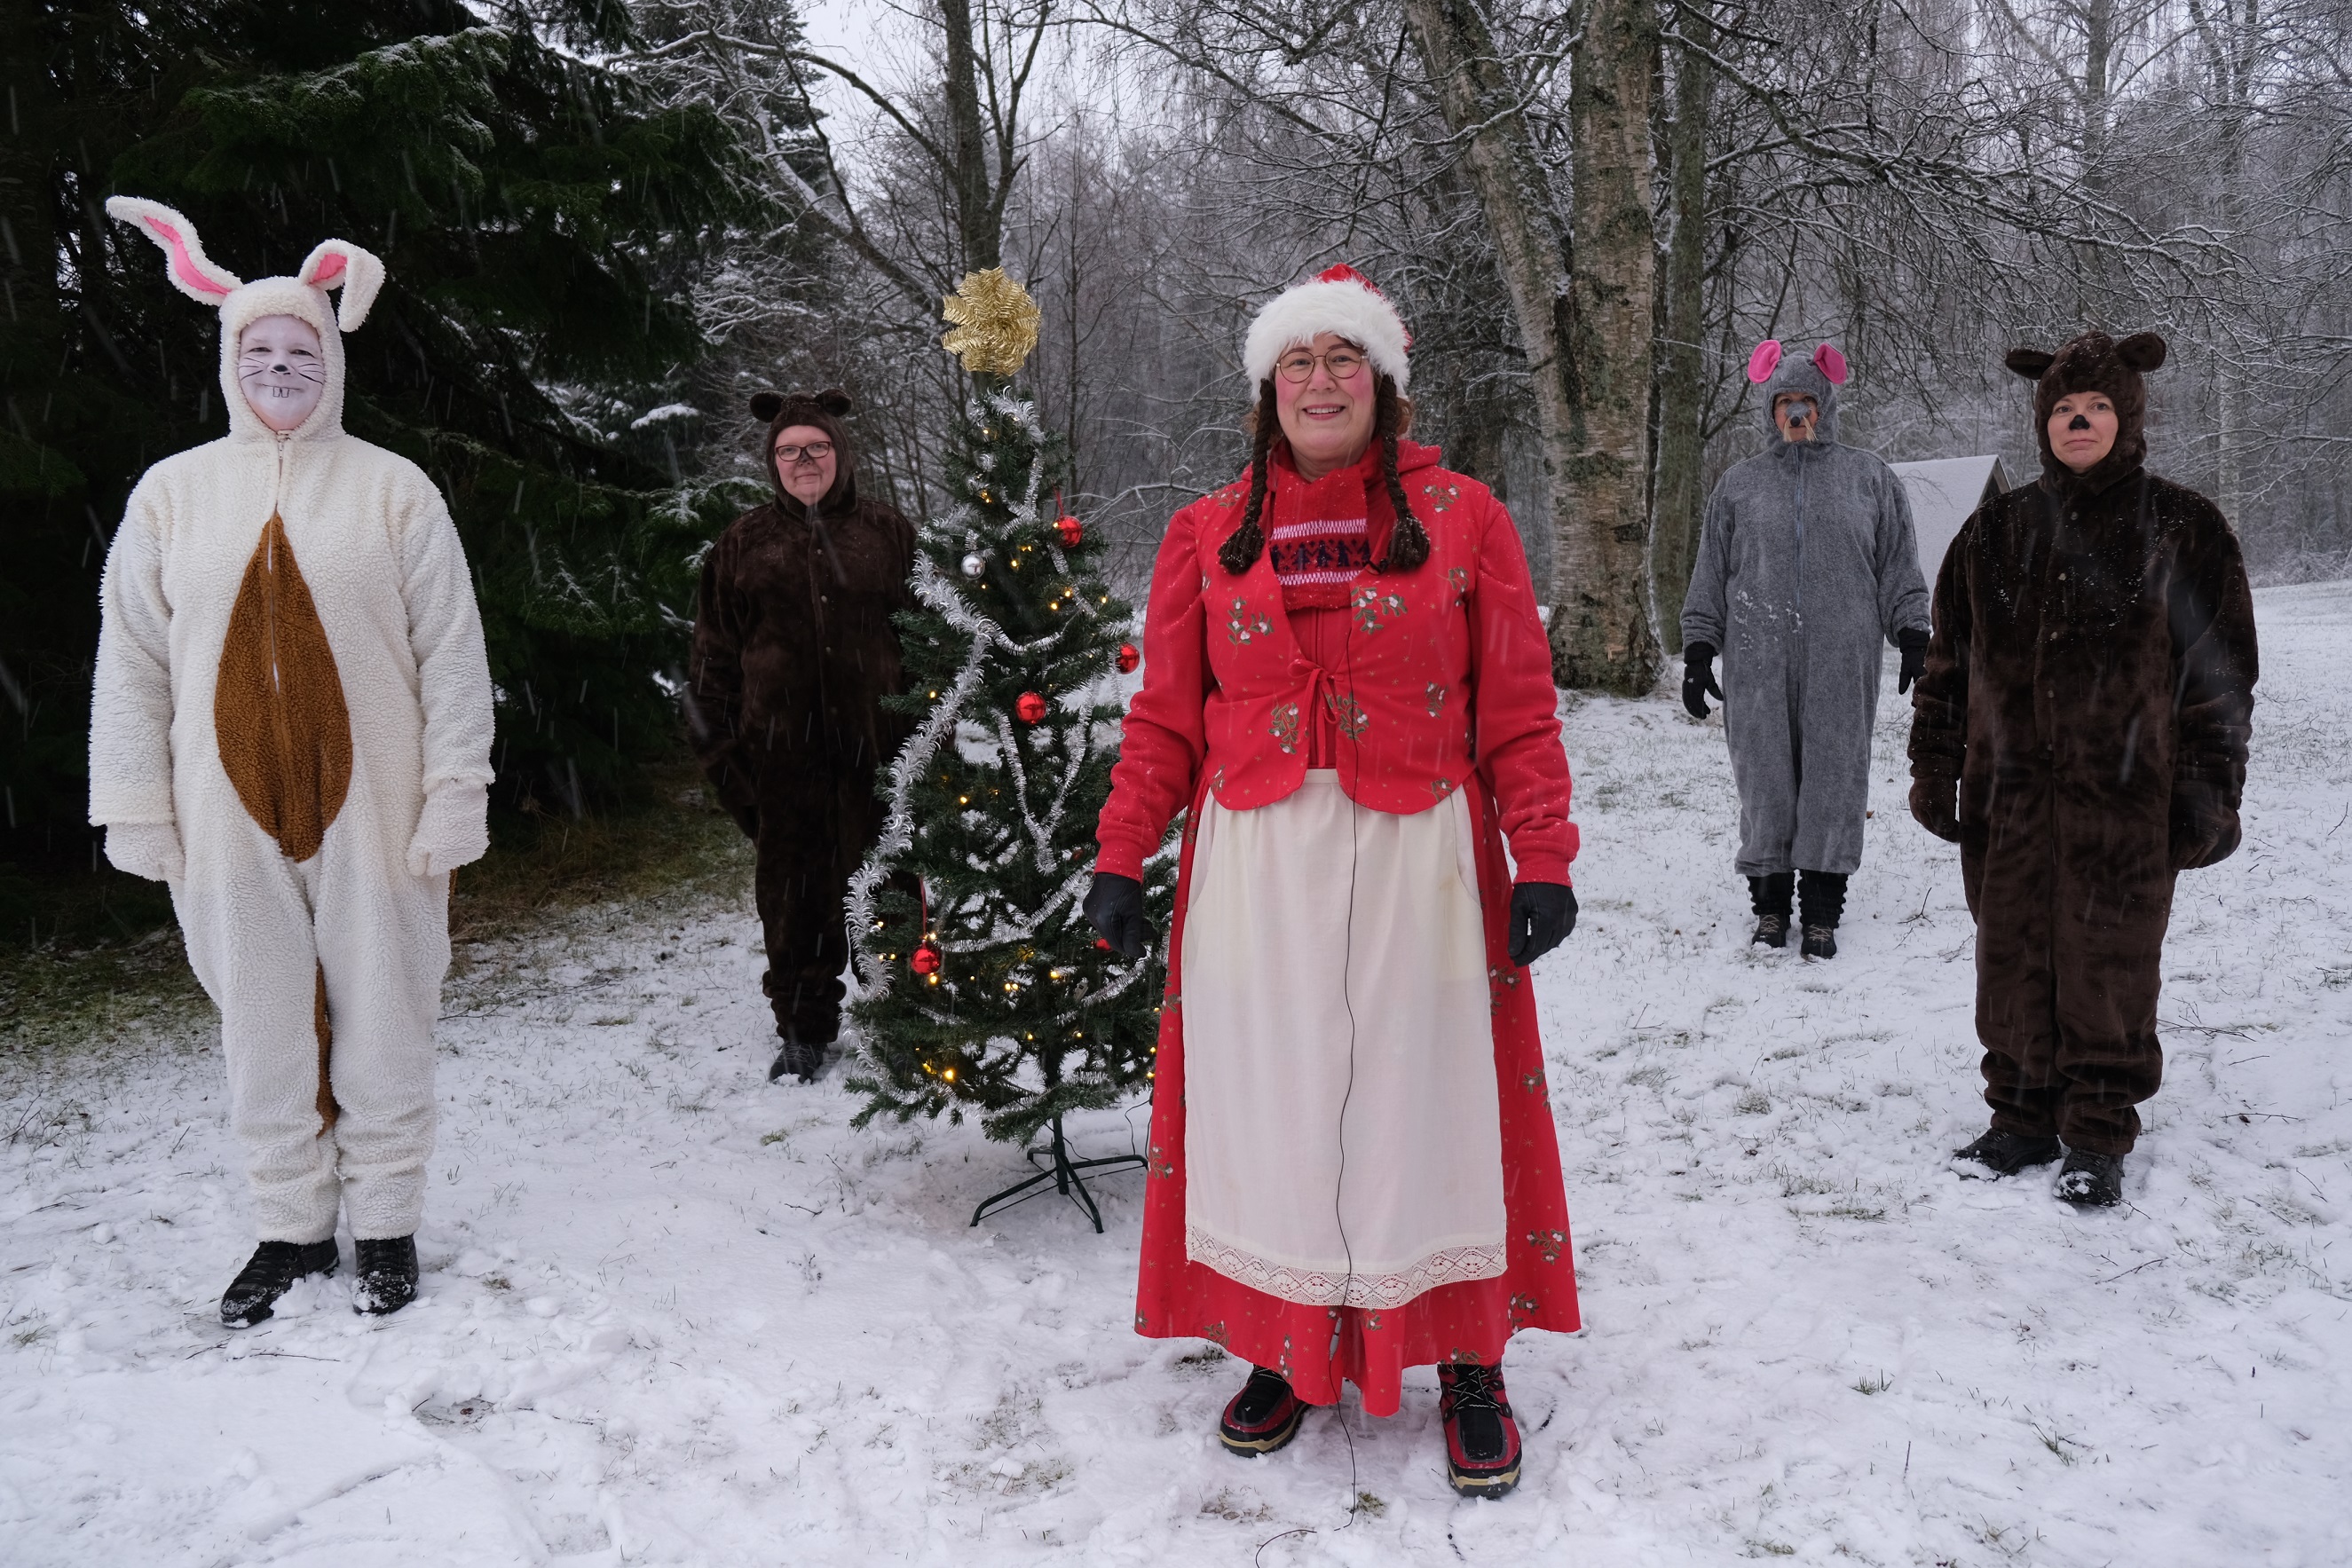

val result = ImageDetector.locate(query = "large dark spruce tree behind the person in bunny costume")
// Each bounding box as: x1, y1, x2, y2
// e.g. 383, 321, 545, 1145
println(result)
0, 0, 757, 934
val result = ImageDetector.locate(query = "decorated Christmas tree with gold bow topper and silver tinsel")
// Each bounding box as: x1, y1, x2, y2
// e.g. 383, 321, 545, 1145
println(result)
849, 268, 1176, 1230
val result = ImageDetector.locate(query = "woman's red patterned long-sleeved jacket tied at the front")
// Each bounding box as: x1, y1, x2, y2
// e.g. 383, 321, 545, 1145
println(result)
1096, 442, 1576, 881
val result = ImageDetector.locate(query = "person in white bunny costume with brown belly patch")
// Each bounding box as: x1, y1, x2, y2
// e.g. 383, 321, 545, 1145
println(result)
90, 195, 492, 1328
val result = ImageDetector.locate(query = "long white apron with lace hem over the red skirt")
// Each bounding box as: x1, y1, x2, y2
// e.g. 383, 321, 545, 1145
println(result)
1183, 768, 1505, 1310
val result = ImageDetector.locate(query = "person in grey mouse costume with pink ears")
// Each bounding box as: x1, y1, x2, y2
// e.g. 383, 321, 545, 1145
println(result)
1682, 341, 1929, 959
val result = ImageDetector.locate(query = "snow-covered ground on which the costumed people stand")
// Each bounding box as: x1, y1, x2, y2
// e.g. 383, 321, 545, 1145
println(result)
0, 586, 2352, 1568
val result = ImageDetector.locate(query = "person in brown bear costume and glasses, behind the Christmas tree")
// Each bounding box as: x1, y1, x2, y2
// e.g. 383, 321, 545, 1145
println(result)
687, 390, 915, 1082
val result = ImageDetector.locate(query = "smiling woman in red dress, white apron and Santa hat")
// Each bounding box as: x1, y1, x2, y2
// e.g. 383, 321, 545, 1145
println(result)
1086, 268, 1578, 1498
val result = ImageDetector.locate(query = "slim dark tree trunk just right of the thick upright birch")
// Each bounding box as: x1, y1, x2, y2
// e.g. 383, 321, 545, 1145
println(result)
1649, 10, 1715, 653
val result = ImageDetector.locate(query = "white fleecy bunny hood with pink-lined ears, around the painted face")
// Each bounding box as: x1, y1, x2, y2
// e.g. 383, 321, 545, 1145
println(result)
106, 195, 383, 439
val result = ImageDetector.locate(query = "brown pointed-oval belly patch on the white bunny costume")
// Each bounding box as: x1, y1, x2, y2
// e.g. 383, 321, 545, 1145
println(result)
212, 513, 351, 860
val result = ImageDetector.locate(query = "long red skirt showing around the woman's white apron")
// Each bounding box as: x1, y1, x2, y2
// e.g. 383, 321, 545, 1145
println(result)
1136, 778, 1578, 1415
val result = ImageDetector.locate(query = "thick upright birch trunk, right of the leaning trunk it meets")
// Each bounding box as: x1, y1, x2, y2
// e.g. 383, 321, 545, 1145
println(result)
1550, 0, 1658, 696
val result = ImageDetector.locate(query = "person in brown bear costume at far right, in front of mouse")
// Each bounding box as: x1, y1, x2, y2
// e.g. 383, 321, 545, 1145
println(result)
1910, 332, 2255, 1206
